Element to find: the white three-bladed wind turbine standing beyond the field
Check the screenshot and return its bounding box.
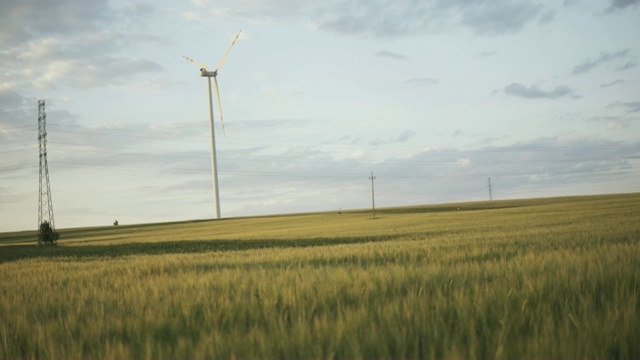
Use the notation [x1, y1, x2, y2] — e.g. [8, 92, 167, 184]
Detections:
[184, 30, 242, 219]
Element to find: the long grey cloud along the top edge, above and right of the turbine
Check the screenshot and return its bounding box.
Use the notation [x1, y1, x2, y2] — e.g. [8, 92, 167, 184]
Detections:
[184, 0, 553, 38]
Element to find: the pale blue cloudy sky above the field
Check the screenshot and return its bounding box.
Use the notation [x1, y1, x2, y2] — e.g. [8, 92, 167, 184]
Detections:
[0, 0, 640, 231]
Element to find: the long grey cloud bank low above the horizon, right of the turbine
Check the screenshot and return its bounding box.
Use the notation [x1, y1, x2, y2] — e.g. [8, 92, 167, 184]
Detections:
[239, 137, 640, 208]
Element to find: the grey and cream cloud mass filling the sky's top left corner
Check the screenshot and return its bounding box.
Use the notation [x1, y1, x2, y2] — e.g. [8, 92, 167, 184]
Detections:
[0, 0, 163, 90]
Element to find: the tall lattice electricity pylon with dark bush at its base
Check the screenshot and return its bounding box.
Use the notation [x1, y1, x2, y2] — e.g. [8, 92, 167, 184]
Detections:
[38, 100, 57, 244]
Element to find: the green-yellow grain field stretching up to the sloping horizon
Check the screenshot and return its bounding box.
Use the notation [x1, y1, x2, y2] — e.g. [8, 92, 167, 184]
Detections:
[0, 194, 640, 359]
